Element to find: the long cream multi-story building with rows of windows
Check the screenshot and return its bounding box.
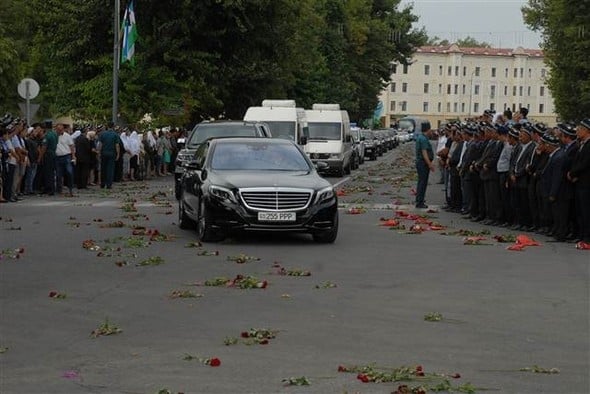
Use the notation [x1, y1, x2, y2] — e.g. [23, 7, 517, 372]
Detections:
[380, 44, 557, 127]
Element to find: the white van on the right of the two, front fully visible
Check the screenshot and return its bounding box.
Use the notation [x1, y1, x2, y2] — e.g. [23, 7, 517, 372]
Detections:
[305, 104, 354, 176]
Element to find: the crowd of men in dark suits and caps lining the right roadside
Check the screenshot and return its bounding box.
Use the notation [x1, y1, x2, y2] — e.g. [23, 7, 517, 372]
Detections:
[424, 108, 590, 242]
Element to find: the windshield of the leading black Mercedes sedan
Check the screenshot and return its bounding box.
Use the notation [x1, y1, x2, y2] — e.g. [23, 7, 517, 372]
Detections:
[211, 142, 310, 171]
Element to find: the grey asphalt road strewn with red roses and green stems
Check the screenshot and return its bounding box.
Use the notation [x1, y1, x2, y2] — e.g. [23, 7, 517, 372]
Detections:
[0, 144, 590, 394]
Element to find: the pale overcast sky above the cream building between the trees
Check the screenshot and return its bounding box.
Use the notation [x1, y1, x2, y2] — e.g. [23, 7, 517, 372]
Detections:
[401, 0, 541, 48]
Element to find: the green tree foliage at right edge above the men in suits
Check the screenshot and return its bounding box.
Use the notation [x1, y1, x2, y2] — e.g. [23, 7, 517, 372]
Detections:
[522, 0, 590, 120]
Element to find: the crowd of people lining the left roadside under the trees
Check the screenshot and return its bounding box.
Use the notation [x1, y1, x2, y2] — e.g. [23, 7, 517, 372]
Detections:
[0, 115, 183, 203]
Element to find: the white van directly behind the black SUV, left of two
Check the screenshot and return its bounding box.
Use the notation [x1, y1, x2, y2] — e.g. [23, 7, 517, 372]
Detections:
[244, 100, 308, 145]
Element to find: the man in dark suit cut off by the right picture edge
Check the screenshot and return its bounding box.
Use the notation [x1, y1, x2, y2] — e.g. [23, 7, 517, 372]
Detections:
[567, 118, 590, 242]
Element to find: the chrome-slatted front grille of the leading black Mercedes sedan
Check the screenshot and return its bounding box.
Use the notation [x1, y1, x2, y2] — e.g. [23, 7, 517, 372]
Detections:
[240, 187, 313, 211]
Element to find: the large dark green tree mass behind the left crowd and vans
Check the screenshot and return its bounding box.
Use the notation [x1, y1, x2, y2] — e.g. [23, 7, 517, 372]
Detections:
[0, 0, 426, 124]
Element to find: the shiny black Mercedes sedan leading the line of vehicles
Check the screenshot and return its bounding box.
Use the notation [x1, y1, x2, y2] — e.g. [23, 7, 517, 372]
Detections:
[178, 138, 338, 243]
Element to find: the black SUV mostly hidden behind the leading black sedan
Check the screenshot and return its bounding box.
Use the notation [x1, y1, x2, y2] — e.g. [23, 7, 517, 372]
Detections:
[174, 120, 272, 200]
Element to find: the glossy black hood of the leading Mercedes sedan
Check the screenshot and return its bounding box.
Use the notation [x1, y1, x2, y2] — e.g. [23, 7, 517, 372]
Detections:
[209, 171, 331, 190]
